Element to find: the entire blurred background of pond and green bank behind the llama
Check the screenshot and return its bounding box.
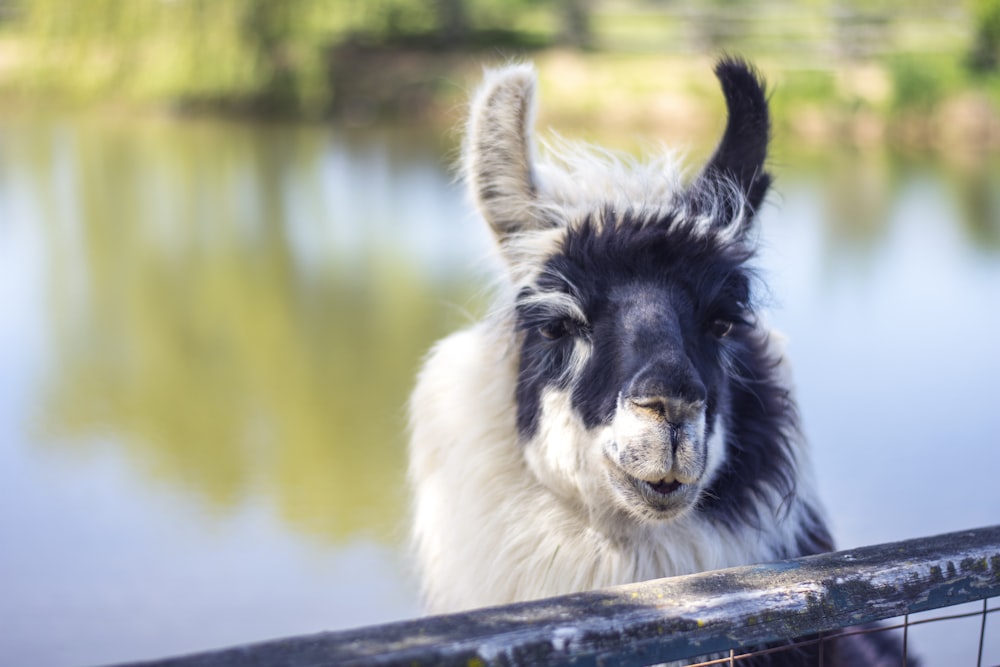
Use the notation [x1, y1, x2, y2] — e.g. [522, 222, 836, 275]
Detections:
[0, 0, 1000, 665]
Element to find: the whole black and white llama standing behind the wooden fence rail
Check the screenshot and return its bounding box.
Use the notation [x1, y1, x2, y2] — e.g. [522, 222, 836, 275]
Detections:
[409, 58, 898, 665]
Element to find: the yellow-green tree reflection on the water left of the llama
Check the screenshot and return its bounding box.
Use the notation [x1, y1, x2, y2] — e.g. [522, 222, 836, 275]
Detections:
[13, 116, 484, 540]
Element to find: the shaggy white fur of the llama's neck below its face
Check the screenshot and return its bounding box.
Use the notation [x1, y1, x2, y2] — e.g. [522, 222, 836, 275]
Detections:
[410, 325, 798, 612]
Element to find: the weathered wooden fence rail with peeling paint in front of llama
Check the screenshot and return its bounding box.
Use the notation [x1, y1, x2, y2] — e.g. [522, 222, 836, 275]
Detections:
[121, 526, 1000, 667]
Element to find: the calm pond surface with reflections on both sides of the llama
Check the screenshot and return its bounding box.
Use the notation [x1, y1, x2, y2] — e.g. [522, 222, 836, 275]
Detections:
[0, 119, 1000, 666]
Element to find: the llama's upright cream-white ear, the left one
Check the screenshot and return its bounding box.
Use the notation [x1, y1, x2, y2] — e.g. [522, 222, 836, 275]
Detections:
[463, 65, 543, 242]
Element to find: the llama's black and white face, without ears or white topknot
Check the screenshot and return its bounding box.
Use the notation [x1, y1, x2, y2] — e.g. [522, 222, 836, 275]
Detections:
[516, 219, 749, 520]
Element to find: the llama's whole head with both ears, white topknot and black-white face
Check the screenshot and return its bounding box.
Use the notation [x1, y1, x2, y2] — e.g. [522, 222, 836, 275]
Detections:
[464, 59, 770, 521]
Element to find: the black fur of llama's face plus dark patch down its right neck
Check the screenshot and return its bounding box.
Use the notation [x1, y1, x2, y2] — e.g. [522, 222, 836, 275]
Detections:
[508, 206, 830, 540]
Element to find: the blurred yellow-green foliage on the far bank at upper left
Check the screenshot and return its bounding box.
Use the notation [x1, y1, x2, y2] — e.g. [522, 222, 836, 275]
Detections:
[8, 0, 336, 112]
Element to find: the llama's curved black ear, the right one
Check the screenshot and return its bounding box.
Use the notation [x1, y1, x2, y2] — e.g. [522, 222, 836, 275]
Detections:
[688, 58, 771, 235]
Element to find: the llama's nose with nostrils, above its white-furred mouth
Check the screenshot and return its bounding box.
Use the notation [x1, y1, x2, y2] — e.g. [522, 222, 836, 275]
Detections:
[622, 361, 708, 423]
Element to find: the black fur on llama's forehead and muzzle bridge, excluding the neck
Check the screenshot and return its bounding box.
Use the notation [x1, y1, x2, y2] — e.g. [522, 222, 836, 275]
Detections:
[518, 213, 747, 436]
